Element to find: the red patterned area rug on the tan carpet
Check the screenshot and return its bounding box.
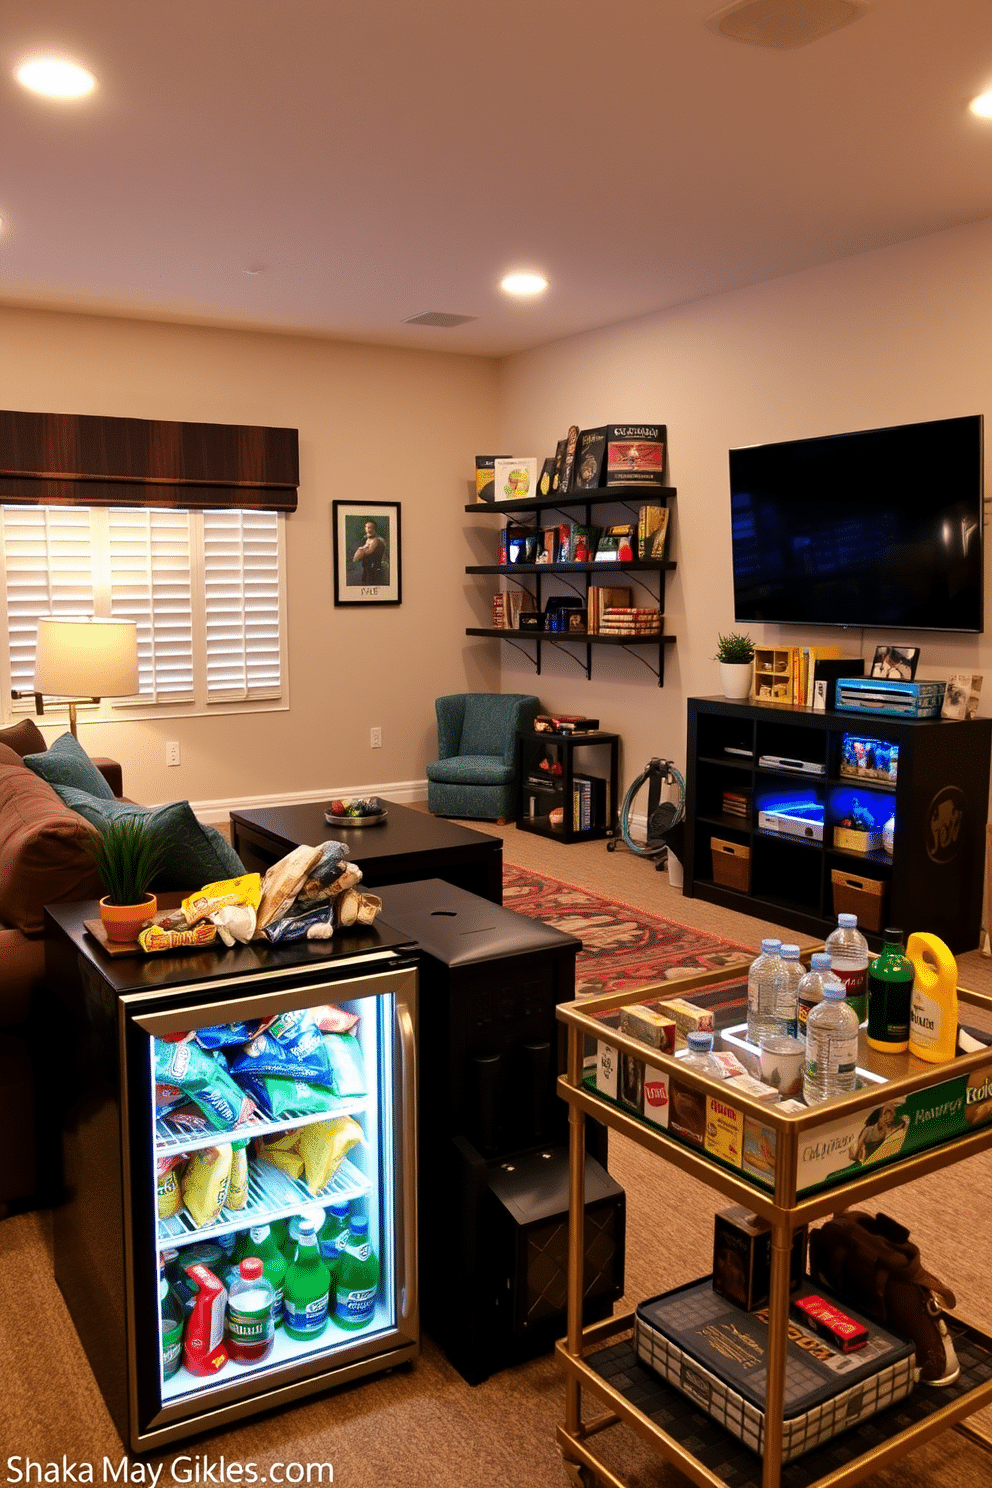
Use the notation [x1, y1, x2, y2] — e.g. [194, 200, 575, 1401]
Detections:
[503, 863, 756, 1000]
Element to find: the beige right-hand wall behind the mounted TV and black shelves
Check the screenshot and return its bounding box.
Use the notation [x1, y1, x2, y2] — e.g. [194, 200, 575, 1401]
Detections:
[500, 222, 992, 809]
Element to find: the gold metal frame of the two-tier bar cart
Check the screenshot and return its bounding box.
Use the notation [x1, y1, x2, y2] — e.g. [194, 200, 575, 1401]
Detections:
[558, 963, 992, 1488]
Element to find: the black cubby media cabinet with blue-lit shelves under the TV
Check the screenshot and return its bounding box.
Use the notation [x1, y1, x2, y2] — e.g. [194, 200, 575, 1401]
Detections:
[683, 698, 992, 952]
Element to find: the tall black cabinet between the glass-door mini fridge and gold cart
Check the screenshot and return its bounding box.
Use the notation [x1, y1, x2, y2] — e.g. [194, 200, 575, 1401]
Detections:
[381, 879, 626, 1384]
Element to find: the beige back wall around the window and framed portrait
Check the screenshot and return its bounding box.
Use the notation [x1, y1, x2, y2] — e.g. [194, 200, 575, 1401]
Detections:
[0, 310, 498, 805]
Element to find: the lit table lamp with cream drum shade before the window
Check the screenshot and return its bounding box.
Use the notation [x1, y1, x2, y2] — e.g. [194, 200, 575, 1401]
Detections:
[34, 615, 138, 738]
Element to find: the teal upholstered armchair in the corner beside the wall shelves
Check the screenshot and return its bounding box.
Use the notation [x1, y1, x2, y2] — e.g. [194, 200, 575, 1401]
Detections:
[427, 692, 541, 821]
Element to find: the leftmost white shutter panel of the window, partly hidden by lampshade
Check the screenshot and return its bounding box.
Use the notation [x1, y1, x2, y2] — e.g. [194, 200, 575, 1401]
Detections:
[0, 506, 94, 692]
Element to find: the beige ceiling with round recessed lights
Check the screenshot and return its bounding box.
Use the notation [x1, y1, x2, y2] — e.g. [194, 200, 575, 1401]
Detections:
[0, 0, 992, 354]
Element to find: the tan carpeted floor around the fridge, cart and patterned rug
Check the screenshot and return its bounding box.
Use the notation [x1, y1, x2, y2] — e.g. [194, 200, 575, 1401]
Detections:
[0, 823, 992, 1488]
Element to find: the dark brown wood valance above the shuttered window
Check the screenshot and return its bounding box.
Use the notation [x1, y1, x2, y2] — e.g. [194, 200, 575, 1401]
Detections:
[0, 409, 299, 512]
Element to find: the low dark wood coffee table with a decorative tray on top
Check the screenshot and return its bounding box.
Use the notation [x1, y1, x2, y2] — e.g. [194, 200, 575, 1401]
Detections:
[231, 801, 503, 905]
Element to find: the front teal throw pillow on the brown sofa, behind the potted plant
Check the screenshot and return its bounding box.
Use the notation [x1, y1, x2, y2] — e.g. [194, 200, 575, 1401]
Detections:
[55, 786, 245, 893]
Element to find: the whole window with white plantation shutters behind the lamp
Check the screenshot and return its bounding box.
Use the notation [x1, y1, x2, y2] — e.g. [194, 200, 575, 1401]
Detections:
[0, 504, 286, 713]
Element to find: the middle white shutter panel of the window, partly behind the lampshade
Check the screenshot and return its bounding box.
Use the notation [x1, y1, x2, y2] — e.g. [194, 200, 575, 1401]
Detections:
[107, 507, 195, 702]
